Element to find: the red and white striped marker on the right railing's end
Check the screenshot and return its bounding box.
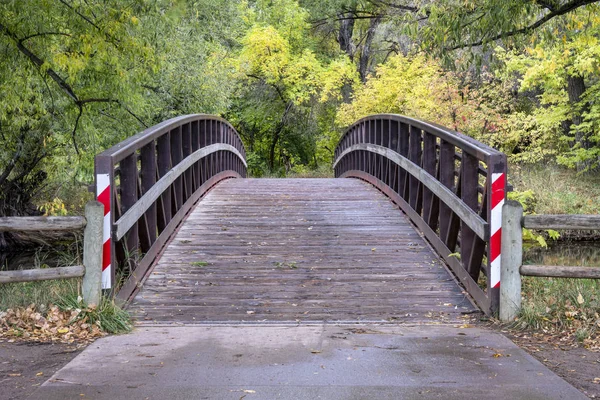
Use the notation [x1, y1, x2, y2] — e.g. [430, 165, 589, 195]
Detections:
[489, 172, 506, 289]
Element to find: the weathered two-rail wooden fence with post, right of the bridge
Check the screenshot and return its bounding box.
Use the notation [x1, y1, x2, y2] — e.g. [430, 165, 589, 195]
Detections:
[500, 201, 600, 321]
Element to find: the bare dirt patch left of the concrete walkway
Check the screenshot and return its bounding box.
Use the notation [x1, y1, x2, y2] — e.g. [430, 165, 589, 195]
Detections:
[0, 341, 83, 400]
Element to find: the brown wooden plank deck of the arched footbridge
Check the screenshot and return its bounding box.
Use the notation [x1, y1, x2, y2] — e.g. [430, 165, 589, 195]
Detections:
[130, 179, 475, 323]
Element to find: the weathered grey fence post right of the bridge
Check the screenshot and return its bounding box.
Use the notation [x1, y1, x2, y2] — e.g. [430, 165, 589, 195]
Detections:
[500, 200, 523, 322]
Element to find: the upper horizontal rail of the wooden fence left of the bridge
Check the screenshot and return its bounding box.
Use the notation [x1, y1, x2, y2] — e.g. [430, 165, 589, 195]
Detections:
[0, 217, 85, 232]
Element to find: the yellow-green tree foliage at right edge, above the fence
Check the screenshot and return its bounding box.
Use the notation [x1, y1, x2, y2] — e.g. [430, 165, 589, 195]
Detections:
[497, 7, 600, 170]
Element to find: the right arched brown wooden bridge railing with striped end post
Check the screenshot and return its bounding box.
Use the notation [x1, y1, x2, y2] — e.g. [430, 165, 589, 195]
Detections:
[334, 114, 506, 314]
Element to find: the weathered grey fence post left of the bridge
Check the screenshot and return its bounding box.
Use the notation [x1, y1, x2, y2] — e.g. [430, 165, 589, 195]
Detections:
[82, 201, 104, 305]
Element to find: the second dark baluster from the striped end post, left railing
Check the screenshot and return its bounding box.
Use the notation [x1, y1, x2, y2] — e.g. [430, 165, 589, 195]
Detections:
[140, 141, 156, 253]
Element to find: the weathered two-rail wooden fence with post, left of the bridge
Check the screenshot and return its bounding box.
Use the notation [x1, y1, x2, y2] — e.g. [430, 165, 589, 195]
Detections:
[0, 201, 104, 304]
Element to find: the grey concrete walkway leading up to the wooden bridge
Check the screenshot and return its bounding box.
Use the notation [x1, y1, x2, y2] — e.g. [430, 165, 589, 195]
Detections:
[31, 325, 586, 400]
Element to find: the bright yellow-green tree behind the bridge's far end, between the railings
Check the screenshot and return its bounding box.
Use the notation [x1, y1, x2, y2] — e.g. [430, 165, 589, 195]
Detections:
[231, 0, 356, 172]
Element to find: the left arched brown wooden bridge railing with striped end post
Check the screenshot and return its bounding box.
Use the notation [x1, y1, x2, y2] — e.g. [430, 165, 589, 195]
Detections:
[95, 114, 247, 301]
